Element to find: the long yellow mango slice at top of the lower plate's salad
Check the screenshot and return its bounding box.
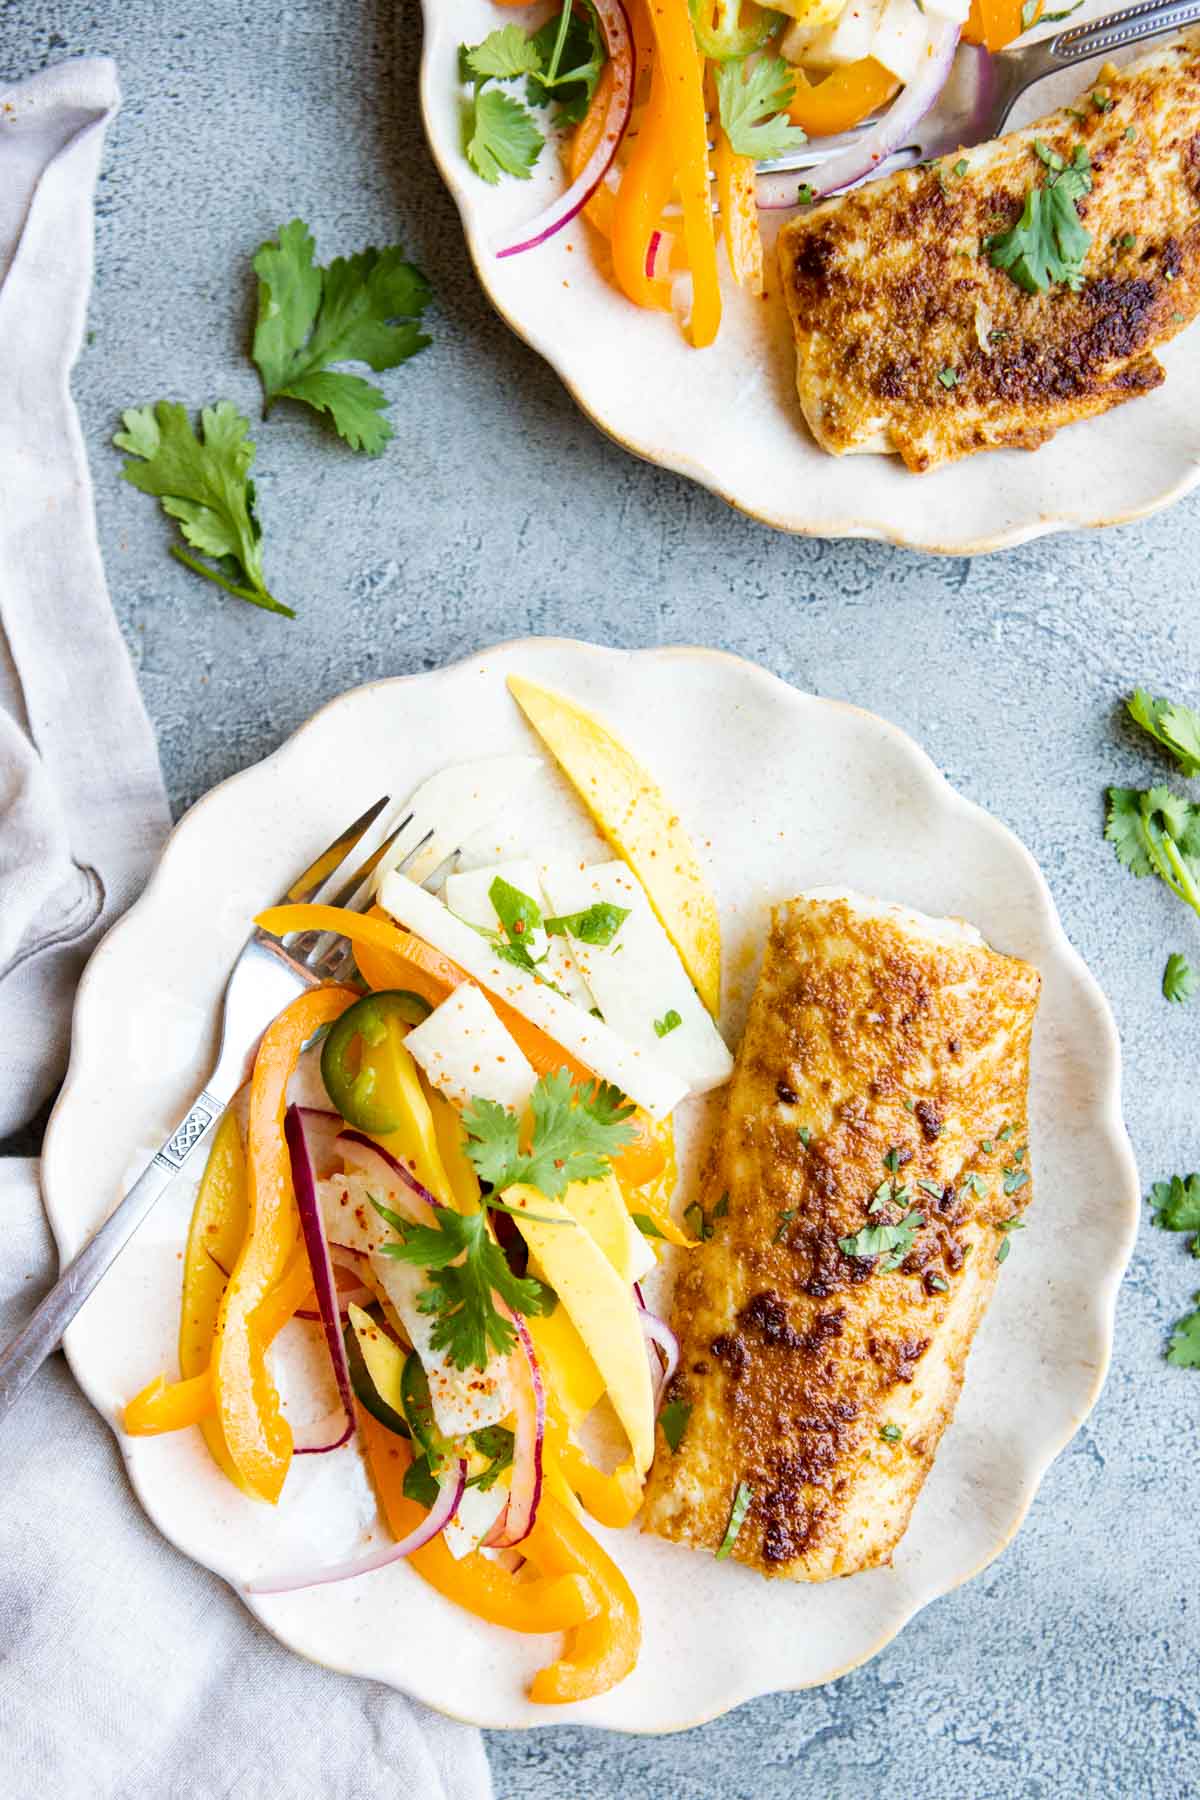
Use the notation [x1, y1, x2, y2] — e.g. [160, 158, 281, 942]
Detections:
[507, 675, 721, 1017]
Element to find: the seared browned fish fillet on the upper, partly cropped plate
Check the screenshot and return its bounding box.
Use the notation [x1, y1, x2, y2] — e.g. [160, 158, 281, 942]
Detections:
[779, 31, 1200, 470]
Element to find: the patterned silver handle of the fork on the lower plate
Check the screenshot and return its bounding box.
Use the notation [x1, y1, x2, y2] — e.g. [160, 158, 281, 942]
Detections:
[0, 1087, 227, 1420]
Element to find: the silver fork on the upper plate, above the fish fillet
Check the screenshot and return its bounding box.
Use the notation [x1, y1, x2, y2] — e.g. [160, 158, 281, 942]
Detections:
[759, 0, 1200, 175]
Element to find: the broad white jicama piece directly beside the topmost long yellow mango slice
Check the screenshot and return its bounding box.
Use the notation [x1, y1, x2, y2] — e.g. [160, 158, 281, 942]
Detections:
[542, 860, 734, 1094]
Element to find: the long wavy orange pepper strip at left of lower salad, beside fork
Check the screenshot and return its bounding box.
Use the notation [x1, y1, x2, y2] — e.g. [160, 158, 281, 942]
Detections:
[212, 988, 358, 1505]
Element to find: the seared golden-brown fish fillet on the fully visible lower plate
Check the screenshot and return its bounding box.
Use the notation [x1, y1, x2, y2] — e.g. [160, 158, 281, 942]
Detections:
[644, 889, 1040, 1580]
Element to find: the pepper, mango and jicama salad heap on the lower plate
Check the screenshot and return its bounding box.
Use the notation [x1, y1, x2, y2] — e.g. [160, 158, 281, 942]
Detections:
[124, 679, 730, 1703]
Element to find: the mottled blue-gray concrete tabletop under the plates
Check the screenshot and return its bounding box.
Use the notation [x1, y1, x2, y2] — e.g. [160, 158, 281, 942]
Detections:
[0, 0, 1200, 1800]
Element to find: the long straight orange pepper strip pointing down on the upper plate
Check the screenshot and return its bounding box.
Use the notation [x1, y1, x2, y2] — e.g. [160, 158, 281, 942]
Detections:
[647, 0, 721, 349]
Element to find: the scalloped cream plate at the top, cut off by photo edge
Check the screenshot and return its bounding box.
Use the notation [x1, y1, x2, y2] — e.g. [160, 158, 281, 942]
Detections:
[421, 0, 1200, 554]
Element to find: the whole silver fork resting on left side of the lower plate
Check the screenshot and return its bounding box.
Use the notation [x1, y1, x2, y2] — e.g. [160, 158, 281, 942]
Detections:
[0, 794, 433, 1420]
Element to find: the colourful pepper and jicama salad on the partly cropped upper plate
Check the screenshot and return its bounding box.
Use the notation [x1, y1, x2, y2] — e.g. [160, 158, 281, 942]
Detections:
[459, 0, 1081, 349]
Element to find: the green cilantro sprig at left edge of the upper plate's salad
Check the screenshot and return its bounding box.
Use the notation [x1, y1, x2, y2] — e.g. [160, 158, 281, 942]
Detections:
[459, 0, 606, 185]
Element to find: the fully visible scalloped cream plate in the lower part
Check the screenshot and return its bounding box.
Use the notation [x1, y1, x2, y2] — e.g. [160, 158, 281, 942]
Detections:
[44, 639, 1139, 1732]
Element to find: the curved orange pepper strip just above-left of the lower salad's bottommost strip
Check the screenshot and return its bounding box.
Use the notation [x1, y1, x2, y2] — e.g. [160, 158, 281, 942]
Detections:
[358, 1408, 599, 1633]
